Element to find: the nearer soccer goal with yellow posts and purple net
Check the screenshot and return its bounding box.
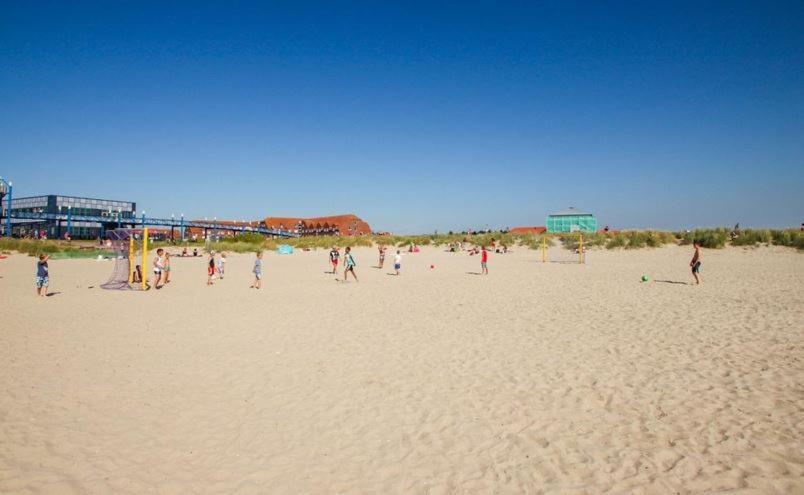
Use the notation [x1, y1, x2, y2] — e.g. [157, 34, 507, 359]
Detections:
[101, 228, 150, 290]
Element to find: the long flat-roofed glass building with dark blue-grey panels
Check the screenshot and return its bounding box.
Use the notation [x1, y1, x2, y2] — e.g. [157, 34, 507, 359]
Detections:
[3, 194, 137, 239]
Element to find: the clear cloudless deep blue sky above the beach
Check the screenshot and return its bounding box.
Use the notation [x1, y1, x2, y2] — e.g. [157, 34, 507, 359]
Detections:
[0, 1, 804, 233]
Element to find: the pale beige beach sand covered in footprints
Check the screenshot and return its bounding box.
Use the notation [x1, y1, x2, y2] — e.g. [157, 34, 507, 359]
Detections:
[0, 247, 804, 494]
